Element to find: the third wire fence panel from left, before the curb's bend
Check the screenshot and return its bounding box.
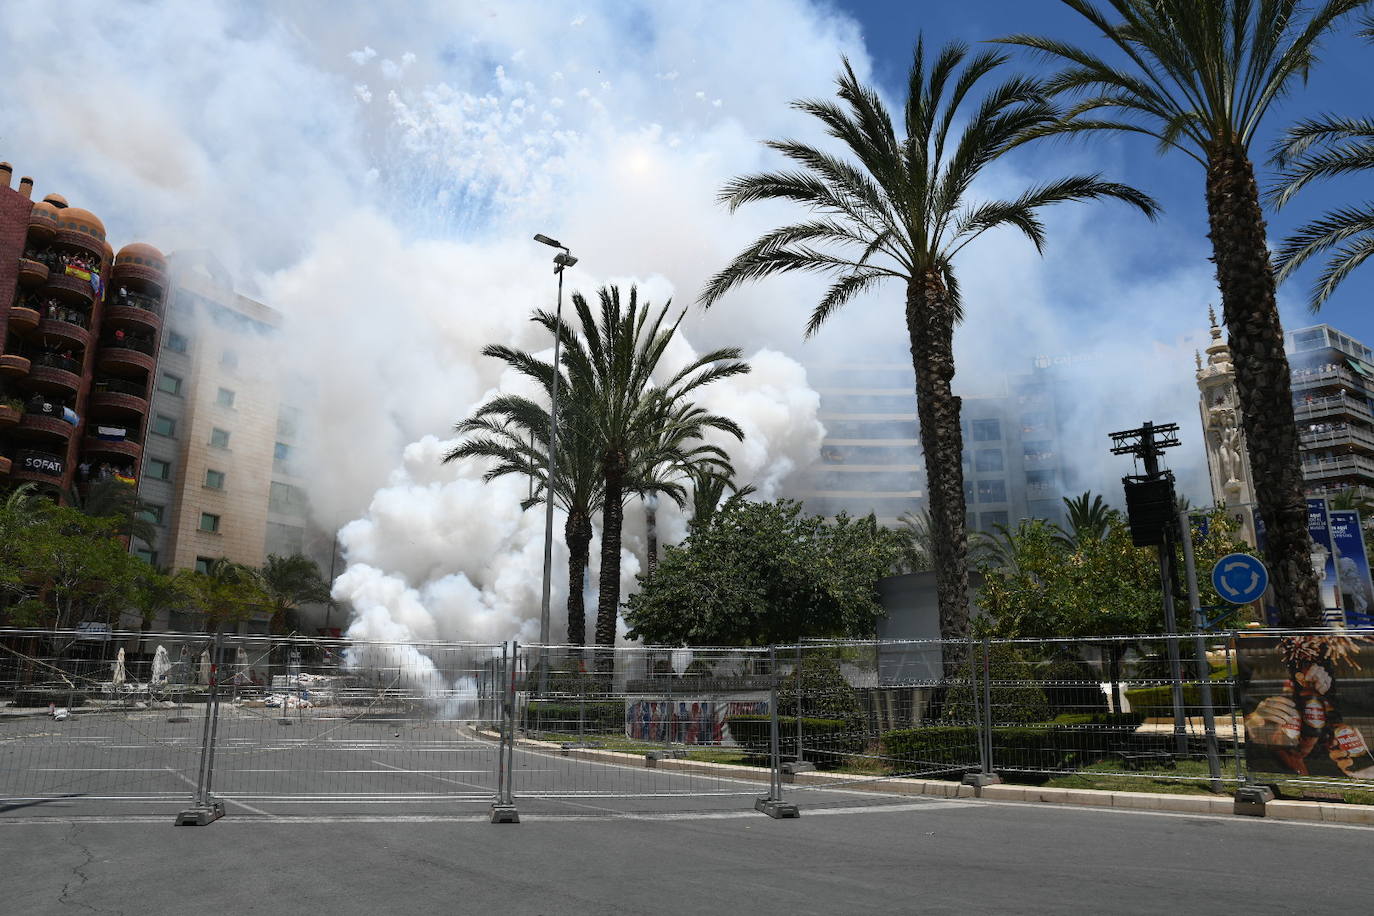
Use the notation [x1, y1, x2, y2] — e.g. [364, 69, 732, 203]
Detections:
[514, 645, 774, 813]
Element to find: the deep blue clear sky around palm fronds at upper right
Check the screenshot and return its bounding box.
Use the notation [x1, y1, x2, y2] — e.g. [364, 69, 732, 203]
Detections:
[831, 0, 1374, 343]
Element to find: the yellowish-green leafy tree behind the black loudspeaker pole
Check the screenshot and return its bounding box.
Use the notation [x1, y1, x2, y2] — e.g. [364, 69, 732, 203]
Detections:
[980, 509, 1248, 709]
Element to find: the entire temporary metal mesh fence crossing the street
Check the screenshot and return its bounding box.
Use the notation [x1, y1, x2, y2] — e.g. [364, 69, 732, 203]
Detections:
[0, 630, 1374, 823]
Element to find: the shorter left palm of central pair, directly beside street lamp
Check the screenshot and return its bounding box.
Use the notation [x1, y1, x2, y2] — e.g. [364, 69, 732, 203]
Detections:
[444, 368, 602, 645]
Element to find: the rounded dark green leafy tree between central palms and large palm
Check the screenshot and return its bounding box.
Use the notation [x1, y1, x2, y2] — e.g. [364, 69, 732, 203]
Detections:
[625, 496, 899, 645]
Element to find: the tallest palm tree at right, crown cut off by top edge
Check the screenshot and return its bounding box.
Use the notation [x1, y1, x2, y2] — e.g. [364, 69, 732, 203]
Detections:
[1000, 0, 1367, 625]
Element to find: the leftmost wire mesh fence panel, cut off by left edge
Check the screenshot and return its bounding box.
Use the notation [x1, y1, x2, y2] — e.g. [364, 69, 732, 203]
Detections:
[0, 629, 209, 814]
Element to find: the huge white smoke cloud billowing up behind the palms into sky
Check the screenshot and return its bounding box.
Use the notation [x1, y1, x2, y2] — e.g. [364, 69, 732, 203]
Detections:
[0, 0, 1231, 640]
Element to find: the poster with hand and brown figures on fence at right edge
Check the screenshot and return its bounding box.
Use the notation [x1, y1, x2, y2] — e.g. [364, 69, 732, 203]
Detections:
[1237, 630, 1374, 781]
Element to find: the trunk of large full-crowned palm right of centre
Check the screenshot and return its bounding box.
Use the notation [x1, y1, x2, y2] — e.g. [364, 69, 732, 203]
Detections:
[907, 269, 969, 645]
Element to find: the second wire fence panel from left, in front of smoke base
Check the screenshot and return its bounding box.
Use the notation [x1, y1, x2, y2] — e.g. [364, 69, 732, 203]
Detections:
[200, 636, 503, 805]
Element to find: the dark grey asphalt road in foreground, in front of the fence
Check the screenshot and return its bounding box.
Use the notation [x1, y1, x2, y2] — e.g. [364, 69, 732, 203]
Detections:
[0, 799, 1374, 916]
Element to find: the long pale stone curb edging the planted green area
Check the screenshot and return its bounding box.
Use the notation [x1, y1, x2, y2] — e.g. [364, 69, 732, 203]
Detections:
[478, 732, 1374, 827]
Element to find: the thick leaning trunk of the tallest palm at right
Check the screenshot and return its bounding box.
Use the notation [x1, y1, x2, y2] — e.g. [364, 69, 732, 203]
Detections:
[1206, 147, 1322, 626]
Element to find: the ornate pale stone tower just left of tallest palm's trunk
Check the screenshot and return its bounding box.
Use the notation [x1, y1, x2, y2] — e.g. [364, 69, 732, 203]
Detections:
[1197, 306, 1254, 545]
